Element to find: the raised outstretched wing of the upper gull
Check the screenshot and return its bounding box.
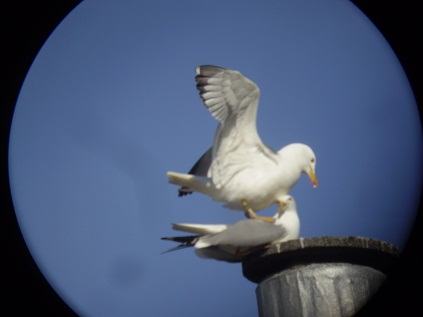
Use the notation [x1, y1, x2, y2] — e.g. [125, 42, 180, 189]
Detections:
[195, 66, 277, 188]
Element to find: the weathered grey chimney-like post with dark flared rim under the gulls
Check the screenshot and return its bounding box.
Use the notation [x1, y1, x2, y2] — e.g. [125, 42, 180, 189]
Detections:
[243, 237, 399, 317]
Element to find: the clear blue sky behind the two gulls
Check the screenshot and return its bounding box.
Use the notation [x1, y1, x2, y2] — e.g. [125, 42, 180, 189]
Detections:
[10, 0, 422, 316]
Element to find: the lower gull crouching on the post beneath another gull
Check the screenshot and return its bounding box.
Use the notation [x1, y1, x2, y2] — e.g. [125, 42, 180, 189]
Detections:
[162, 195, 300, 262]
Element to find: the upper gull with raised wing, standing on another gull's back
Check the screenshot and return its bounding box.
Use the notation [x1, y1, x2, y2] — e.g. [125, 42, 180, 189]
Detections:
[167, 65, 318, 222]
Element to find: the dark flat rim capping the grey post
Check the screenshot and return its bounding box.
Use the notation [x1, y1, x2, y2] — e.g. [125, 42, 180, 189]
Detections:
[242, 237, 400, 283]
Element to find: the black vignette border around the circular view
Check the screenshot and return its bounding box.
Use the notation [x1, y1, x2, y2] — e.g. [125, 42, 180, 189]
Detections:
[0, 0, 423, 317]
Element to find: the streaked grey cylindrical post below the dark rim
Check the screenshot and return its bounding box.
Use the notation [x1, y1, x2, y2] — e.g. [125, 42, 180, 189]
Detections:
[256, 263, 386, 317]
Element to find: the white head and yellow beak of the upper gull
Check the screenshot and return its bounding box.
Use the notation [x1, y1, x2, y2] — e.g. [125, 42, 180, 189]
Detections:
[280, 143, 318, 188]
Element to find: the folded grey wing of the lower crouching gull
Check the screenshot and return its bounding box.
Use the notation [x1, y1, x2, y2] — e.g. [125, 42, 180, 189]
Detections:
[200, 219, 287, 247]
